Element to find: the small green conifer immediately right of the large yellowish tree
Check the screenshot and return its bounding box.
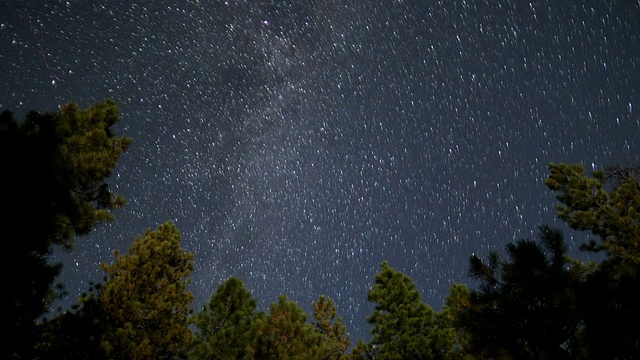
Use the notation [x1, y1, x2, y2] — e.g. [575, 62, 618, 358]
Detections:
[190, 277, 256, 359]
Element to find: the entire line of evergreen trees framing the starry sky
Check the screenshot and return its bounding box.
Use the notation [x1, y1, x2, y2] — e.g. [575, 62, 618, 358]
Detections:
[0, 100, 640, 360]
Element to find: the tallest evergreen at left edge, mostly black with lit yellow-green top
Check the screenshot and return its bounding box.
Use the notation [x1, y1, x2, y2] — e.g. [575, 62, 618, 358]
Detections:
[0, 100, 130, 358]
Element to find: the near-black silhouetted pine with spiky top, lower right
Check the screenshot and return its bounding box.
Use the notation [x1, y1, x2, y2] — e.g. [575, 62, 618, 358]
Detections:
[459, 226, 581, 359]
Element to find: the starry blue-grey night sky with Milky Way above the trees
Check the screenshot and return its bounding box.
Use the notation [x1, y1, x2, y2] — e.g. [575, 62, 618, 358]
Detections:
[0, 0, 640, 340]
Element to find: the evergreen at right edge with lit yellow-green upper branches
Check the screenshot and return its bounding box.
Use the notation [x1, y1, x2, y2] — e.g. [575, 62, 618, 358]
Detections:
[545, 164, 640, 359]
